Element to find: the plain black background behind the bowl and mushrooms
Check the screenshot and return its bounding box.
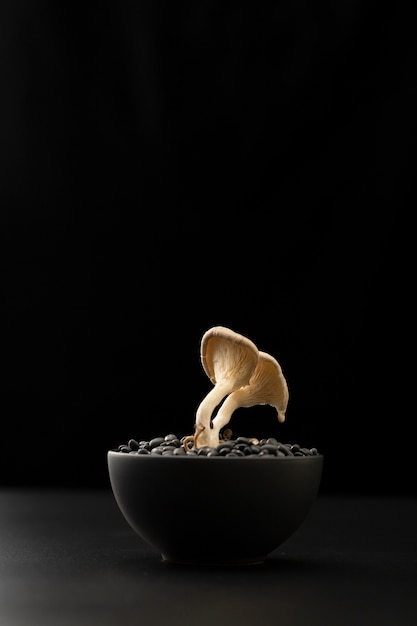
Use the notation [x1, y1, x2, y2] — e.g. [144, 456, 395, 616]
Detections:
[0, 0, 416, 493]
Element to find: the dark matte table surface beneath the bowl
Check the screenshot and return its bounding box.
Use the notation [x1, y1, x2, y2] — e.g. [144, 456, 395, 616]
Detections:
[0, 489, 417, 626]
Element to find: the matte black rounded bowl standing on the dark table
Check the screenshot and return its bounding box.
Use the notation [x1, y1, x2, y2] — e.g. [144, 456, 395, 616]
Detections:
[107, 451, 323, 565]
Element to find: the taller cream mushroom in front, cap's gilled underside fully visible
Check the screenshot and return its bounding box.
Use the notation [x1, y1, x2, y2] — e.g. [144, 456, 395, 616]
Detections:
[193, 326, 259, 448]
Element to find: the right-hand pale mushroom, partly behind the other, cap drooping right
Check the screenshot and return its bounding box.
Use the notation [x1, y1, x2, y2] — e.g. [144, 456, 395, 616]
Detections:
[213, 351, 289, 432]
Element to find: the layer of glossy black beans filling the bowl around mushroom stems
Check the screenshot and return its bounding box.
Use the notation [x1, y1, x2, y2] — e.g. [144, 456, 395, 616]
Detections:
[115, 434, 319, 457]
